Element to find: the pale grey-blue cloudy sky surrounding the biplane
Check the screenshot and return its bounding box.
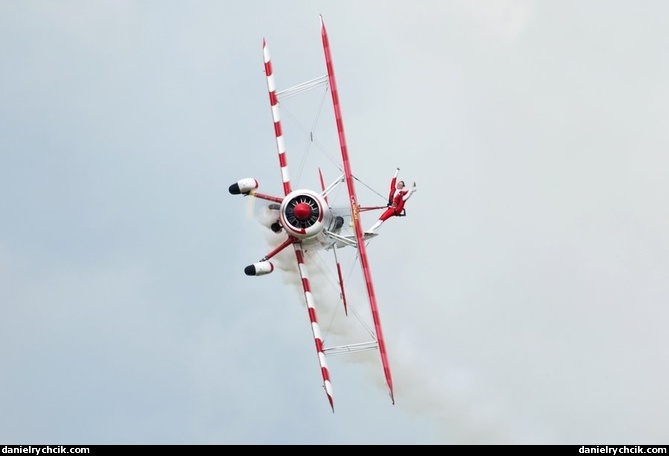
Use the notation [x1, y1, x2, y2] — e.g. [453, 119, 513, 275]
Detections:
[0, 0, 669, 444]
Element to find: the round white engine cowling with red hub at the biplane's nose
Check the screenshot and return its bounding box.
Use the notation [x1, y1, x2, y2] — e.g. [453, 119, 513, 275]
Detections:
[279, 190, 332, 239]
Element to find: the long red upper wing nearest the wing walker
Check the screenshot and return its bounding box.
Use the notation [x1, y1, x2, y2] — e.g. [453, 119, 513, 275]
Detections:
[318, 16, 395, 404]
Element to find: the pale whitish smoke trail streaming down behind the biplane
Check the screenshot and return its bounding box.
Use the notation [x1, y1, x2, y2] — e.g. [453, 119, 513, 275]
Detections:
[253, 208, 546, 444]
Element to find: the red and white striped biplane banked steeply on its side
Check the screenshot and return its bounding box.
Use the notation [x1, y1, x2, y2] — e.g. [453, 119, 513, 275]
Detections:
[229, 16, 395, 412]
